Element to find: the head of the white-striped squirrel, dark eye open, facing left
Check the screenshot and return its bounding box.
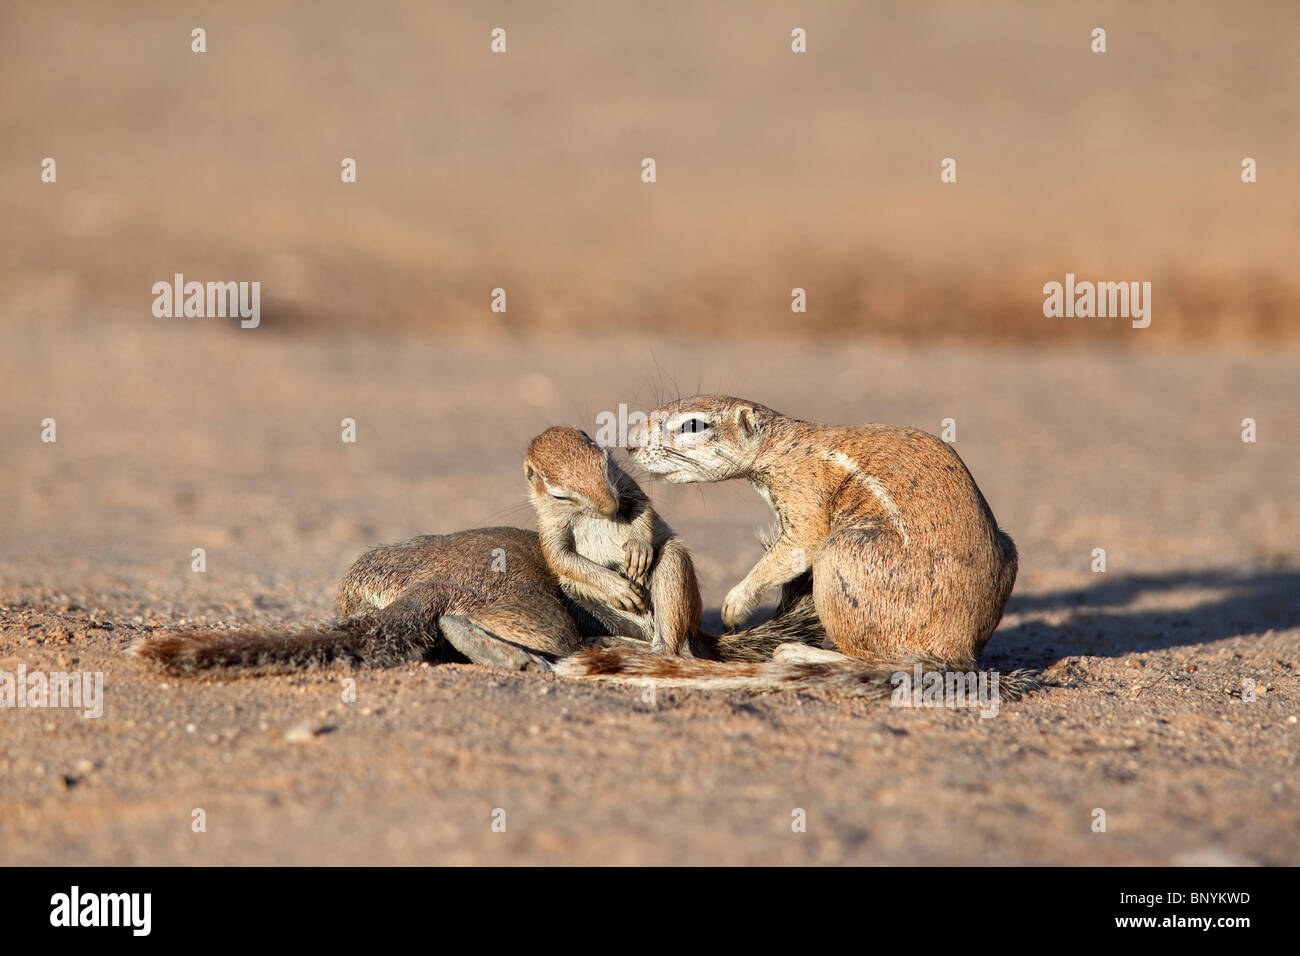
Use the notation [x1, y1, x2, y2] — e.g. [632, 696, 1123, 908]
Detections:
[628, 395, 780, 483]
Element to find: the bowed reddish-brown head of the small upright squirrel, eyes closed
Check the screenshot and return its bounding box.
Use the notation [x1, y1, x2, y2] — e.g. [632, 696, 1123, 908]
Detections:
[524, 425, 619, 518]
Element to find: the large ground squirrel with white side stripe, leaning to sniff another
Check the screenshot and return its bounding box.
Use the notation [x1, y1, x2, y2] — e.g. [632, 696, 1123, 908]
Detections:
[568, 395, 1017, 687]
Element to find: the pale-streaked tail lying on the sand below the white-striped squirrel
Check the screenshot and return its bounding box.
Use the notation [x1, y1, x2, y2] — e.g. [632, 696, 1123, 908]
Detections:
[555, 645, 1039, 700]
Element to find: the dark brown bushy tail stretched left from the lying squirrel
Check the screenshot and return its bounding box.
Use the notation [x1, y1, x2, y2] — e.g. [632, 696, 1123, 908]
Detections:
[130, 615, 437, 676]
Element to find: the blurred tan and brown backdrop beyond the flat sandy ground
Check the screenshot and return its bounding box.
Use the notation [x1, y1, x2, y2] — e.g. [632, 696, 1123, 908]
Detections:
[0, 1, 1300, 347]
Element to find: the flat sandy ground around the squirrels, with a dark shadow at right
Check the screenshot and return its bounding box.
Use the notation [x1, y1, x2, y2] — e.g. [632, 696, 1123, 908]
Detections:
[0, 316, 1300, 864]
